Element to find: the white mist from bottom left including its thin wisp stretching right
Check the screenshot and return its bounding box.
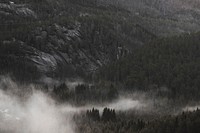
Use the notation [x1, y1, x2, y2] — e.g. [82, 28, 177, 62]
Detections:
[0, 77, 153, 133]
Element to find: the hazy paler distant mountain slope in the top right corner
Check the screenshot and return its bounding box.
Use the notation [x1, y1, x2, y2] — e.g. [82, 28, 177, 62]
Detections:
[104, 0, 200, 36]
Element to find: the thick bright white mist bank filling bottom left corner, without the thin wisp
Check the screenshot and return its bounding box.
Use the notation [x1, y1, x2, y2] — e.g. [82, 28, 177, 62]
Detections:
[0, 91, 74, 133]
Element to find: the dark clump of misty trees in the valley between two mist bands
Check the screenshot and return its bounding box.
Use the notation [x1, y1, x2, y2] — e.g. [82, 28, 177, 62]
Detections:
[52, 83, 119, 105]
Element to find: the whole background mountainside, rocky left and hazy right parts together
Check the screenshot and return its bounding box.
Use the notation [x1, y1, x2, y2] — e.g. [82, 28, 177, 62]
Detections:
[0, 0, 200, 80]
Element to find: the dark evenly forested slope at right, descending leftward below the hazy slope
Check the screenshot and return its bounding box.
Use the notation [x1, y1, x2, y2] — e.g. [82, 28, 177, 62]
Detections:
[98, 33, 200, 101]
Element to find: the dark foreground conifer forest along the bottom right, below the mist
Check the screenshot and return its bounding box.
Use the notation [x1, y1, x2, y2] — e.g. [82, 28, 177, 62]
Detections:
[75, 108, 200, 133]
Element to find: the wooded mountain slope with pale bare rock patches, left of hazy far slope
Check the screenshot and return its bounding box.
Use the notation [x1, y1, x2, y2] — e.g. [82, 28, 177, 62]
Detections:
[0, 0, 155, 79]
